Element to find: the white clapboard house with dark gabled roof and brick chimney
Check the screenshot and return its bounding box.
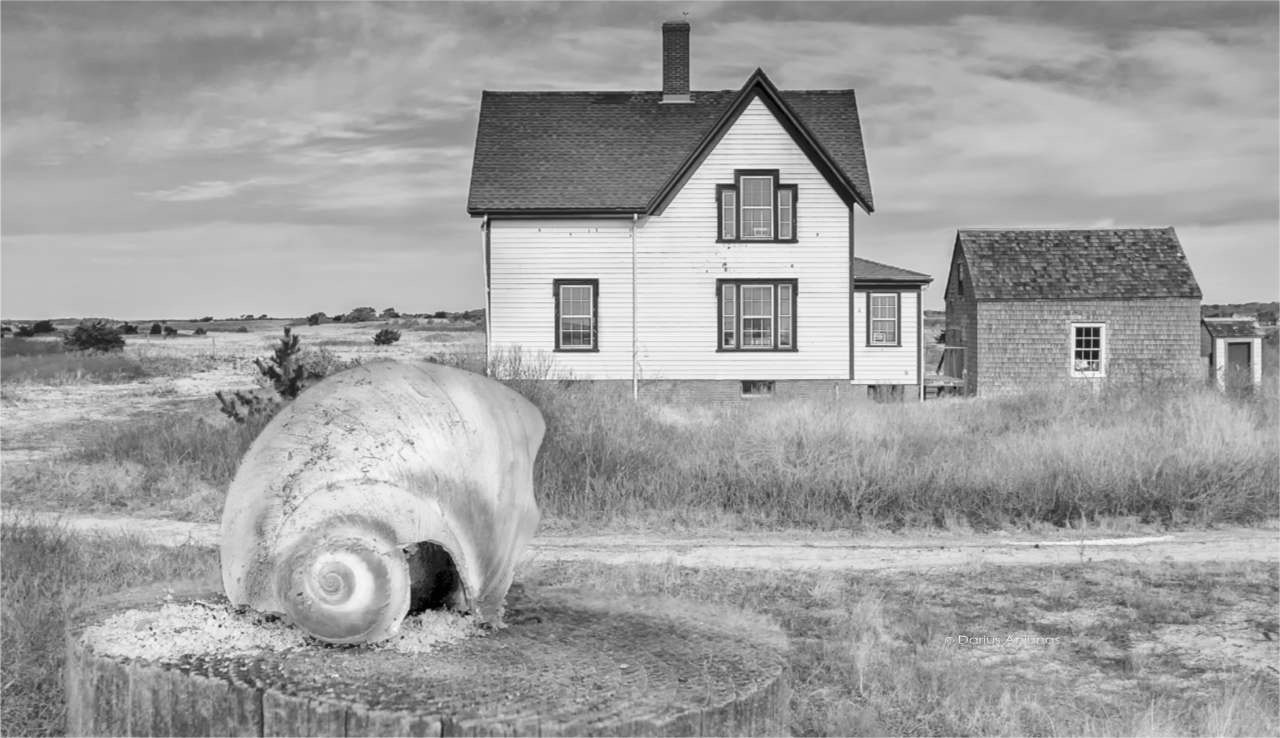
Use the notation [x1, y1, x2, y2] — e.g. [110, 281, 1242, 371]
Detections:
[467, 22, 931, 400]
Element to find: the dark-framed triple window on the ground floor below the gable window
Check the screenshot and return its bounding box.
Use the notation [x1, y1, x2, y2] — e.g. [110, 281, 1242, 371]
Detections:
[716, 279, 796, 350]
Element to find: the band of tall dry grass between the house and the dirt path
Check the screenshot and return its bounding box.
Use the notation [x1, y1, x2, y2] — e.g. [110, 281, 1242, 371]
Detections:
[522, 382, 1280, 527]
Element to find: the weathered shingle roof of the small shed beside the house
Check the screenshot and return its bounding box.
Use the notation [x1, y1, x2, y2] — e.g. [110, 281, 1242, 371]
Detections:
[947, 228, 1201, 299]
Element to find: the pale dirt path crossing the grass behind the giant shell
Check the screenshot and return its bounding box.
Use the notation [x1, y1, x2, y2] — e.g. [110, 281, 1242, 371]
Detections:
[4, 510, 1280, 570]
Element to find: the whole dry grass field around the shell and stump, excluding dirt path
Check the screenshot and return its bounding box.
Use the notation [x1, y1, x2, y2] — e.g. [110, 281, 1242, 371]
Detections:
[0, 321, 1280, 735]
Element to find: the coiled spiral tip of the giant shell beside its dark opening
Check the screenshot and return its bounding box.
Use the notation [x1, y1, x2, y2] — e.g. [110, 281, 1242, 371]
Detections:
[276, 522, 411, 643]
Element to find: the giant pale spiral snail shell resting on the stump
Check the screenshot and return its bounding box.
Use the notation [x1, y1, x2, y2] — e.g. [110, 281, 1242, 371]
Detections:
[221, 362, 545, 643]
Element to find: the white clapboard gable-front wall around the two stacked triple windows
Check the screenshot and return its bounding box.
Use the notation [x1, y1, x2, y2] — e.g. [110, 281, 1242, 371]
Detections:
[636, 100, 850, 380]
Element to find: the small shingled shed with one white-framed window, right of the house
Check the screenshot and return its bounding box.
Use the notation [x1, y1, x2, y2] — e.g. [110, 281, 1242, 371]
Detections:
[943, 228, 1203, 395]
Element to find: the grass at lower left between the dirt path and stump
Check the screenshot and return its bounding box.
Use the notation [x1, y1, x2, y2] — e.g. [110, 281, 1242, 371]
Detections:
[0, 522, 218, 735]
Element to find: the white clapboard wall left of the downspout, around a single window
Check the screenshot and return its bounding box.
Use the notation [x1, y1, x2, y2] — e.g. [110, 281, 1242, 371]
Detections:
[489, 219, 631, 379]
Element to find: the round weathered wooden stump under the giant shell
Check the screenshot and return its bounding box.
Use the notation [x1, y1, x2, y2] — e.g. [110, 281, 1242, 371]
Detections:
[67, 586, 790, 735]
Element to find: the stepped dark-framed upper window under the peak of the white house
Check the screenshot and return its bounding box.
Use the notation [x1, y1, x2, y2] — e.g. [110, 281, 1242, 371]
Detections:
[716, 169, 796, 242]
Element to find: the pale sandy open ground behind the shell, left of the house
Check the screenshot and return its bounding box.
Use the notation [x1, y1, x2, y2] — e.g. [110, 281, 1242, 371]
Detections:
[0, 322, 484, 463]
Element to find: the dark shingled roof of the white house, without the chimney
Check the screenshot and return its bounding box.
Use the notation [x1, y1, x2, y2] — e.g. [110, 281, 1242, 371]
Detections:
[467, 69, 873, 215]
